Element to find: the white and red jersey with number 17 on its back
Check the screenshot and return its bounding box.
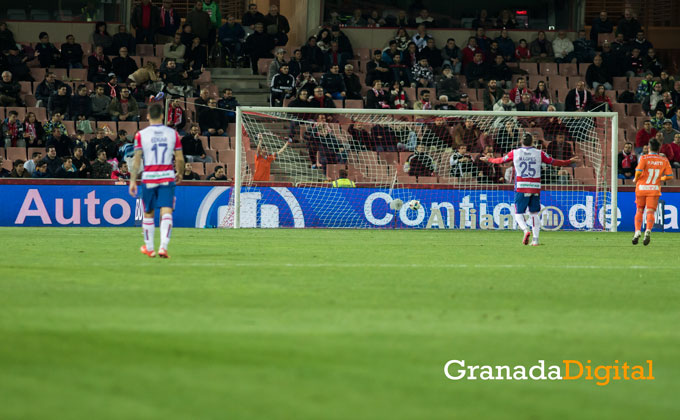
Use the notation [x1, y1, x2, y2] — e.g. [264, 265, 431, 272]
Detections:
[135, 125, 182, 184]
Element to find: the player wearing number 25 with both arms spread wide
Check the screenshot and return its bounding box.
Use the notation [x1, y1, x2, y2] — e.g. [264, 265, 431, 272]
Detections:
[480, 134, 578, 246]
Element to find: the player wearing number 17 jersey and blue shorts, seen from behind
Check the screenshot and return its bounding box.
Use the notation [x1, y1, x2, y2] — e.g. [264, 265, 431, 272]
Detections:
[130, 104, 184, 258]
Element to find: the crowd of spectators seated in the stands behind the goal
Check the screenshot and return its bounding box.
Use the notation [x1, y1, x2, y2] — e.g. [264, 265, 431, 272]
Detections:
[0, 0, 680, 180]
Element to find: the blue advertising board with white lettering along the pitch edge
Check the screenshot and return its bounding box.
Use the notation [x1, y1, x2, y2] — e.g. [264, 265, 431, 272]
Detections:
[0, 182, 680, 232]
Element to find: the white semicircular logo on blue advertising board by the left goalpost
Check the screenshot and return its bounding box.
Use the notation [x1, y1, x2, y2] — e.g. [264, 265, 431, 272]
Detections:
[195, 187, 305, 228]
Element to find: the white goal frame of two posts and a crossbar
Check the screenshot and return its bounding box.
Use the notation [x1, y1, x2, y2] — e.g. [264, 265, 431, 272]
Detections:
[233, 106, 619, 232]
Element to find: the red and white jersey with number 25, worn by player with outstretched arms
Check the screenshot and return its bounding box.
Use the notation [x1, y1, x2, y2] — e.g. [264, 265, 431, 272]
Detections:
[489, 146, 571, 194]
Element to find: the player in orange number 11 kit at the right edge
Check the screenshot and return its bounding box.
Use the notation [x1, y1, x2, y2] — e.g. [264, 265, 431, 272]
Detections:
[633, 139, 673, 245]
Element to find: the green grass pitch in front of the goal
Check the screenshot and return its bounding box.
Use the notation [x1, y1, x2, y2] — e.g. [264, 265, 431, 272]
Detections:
[0, 228, 680, 419]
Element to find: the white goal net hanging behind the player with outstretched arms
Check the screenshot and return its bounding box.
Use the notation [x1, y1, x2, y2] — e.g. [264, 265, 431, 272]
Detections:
[226, 107, 618, 230]
